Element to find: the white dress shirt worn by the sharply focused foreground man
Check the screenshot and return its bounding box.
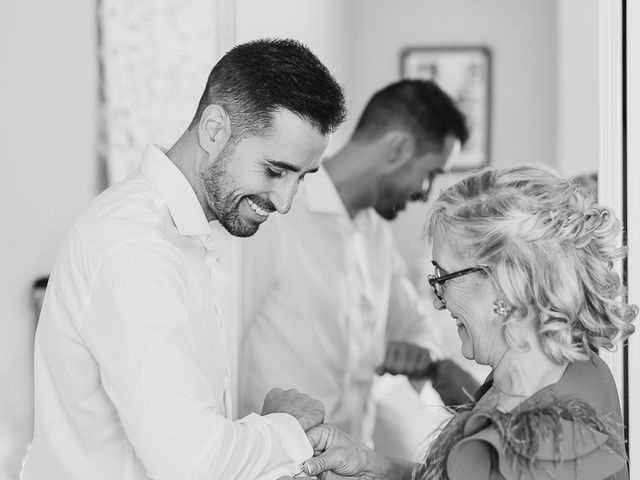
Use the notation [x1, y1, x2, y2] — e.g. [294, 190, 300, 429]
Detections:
[22, 147, 312, 480]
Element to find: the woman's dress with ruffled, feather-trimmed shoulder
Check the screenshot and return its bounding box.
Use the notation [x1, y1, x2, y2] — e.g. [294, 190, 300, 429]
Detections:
[414, 357, 627, 480]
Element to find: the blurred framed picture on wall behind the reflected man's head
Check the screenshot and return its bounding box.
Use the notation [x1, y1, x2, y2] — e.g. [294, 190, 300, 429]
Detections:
[400, 46, 491, 171]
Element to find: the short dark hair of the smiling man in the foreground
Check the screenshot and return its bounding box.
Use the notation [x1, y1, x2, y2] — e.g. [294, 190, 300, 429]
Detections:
[189, 39, 346, 141]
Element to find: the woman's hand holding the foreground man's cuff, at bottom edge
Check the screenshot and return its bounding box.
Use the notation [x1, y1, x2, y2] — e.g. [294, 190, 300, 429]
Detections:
[304, 423, 413, 480]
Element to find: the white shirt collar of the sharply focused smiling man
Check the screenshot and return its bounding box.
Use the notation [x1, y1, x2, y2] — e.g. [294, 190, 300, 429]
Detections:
[138, 145, 214, 236]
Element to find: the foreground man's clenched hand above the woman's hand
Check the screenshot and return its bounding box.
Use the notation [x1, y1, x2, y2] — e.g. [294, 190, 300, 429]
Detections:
[262, 388, 324, 432]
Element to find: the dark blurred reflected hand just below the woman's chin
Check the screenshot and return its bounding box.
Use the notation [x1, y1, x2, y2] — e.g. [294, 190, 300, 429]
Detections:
[429, 359, 480, 406]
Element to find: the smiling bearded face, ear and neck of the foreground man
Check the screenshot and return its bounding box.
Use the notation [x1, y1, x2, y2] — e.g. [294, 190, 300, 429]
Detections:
[167, 105, 328, 237]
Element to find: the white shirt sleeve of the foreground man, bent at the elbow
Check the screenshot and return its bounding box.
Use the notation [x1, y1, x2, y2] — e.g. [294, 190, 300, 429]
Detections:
[80, 242, 312, 480]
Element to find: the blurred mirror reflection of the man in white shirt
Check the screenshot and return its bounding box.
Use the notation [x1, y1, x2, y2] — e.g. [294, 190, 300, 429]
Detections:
[239, 80, 477, 440]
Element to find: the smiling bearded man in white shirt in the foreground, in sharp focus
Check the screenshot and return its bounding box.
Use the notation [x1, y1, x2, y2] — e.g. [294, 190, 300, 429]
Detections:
[22, 40, 344, 480]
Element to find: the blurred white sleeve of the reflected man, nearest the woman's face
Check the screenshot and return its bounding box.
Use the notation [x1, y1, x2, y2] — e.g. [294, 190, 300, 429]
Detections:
[387, 232, 442, 358]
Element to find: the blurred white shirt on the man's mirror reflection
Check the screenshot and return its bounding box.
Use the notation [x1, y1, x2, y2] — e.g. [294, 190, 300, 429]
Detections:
[239, 168, 438, 440]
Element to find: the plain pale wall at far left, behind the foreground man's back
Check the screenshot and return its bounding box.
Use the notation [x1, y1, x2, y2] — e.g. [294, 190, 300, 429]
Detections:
[0, 0, 99, 480]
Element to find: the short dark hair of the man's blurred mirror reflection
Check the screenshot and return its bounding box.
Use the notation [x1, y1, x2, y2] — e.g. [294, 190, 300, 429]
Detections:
[352, 80, 469, 152]
